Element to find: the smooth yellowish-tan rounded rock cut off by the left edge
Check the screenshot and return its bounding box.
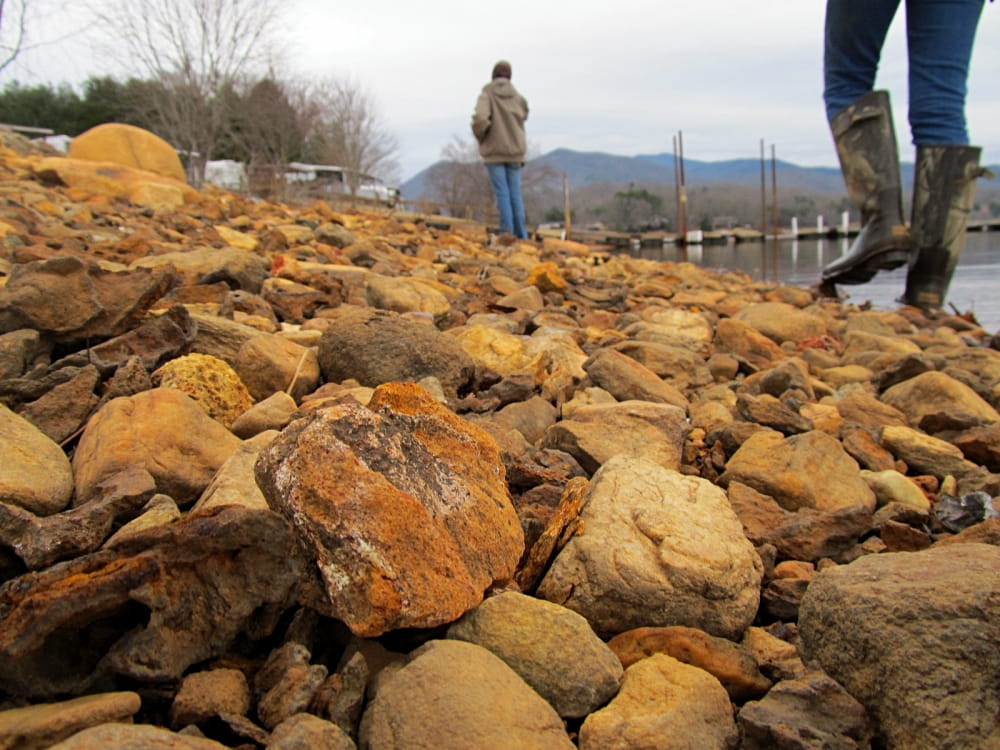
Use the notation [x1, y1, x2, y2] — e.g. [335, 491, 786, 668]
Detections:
[0, 404, 73, 516]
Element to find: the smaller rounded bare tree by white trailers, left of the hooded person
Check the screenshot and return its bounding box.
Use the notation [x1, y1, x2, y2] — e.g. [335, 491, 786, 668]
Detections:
[311, 78, 399, 194]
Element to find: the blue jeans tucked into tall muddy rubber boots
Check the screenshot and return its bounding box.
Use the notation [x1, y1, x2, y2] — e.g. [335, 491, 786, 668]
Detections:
[823, 0, 984, 145]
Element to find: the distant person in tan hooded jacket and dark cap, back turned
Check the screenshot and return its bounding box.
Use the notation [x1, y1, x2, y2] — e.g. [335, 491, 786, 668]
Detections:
[472, 60, 528, 244]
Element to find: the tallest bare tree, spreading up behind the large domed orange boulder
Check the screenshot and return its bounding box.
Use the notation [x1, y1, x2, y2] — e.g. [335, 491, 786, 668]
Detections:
[96, 0, 284, 185]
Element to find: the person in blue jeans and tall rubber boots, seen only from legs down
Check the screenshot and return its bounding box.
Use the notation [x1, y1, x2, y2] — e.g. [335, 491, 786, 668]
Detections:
[821, 0, 989, 311]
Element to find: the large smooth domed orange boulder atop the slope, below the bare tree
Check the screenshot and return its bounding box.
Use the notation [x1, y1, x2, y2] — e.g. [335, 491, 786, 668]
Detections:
[68, 122, 185, 182]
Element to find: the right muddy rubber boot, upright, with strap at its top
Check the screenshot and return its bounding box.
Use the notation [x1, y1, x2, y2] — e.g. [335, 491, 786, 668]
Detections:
[903, 146, 992, 311]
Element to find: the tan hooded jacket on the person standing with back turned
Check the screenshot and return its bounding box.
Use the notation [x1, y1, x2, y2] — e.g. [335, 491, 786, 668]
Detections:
[472, 78, 528, 164]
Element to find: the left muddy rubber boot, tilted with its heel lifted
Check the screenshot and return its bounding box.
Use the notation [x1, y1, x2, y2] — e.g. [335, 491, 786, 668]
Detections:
[822, 91, 912, 286]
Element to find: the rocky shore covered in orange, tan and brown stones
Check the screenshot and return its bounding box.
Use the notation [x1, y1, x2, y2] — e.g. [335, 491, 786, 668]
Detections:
[0, 128, 1000, 750]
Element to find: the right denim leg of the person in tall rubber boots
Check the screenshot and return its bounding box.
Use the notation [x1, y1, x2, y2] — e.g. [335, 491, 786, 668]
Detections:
[906, 0, 983, 146]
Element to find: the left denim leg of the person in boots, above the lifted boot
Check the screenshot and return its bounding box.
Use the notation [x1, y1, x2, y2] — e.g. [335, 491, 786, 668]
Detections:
[823, 0, 900, 120]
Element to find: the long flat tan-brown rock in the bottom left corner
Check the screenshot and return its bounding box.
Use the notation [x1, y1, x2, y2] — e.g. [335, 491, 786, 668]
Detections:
[0, 692, 141, 750]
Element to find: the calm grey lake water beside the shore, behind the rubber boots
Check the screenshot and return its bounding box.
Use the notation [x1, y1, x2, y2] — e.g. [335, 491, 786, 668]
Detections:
[635, 232, 1000, 333]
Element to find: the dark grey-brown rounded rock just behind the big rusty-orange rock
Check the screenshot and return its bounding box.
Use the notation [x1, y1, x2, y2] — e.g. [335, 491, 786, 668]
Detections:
[319, 311, 475, 394]
